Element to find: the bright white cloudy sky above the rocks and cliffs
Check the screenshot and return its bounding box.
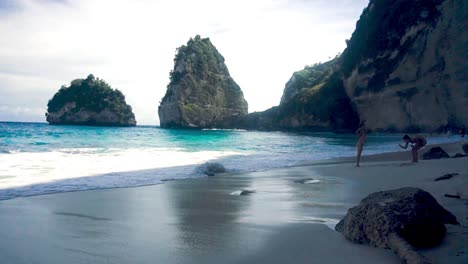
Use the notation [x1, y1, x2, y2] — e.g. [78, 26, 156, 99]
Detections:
[0, 0, 368, 125]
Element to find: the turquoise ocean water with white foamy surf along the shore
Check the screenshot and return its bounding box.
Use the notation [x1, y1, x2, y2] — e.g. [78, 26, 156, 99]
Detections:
[0, 122, 459, 200]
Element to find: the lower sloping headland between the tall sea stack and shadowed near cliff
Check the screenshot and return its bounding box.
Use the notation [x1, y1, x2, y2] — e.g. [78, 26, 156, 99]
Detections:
[231, 62, 359, 131]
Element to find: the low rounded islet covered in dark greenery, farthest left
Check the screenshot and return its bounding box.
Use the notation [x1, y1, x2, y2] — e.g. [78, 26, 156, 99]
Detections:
[46, 74, 136, 126]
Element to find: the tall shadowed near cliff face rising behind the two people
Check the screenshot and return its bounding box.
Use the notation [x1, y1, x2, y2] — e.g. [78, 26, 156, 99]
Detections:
[341, 0, 468, 131]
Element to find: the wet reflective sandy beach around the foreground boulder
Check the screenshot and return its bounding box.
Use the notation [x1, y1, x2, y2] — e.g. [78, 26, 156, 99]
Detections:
[0, 141, 468, 264]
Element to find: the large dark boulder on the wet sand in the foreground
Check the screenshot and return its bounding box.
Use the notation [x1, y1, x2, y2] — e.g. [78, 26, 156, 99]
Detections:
[335, 187, 458, 263]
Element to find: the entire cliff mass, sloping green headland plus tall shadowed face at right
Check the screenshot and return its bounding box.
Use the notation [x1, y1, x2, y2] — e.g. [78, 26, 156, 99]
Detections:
[239, 0, 468, 132]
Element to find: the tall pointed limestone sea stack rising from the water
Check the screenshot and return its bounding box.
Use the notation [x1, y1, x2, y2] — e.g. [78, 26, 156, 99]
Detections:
[158, 35, 248, 129]
